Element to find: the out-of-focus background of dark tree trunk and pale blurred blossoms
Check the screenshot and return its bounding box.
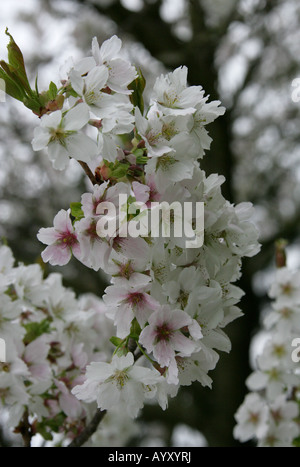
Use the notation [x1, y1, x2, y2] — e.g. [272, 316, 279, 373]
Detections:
[0, 0, 300, 446]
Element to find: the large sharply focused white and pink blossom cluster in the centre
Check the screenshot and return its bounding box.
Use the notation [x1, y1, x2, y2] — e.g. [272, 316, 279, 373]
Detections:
[29, 36, 259, 417]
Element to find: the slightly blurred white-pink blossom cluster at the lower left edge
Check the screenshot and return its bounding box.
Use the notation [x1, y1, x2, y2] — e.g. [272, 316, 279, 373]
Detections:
[0, 246, 125, 439]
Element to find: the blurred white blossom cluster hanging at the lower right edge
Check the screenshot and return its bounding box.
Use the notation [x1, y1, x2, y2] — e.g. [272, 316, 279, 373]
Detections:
[234, 266, 300, 447]
